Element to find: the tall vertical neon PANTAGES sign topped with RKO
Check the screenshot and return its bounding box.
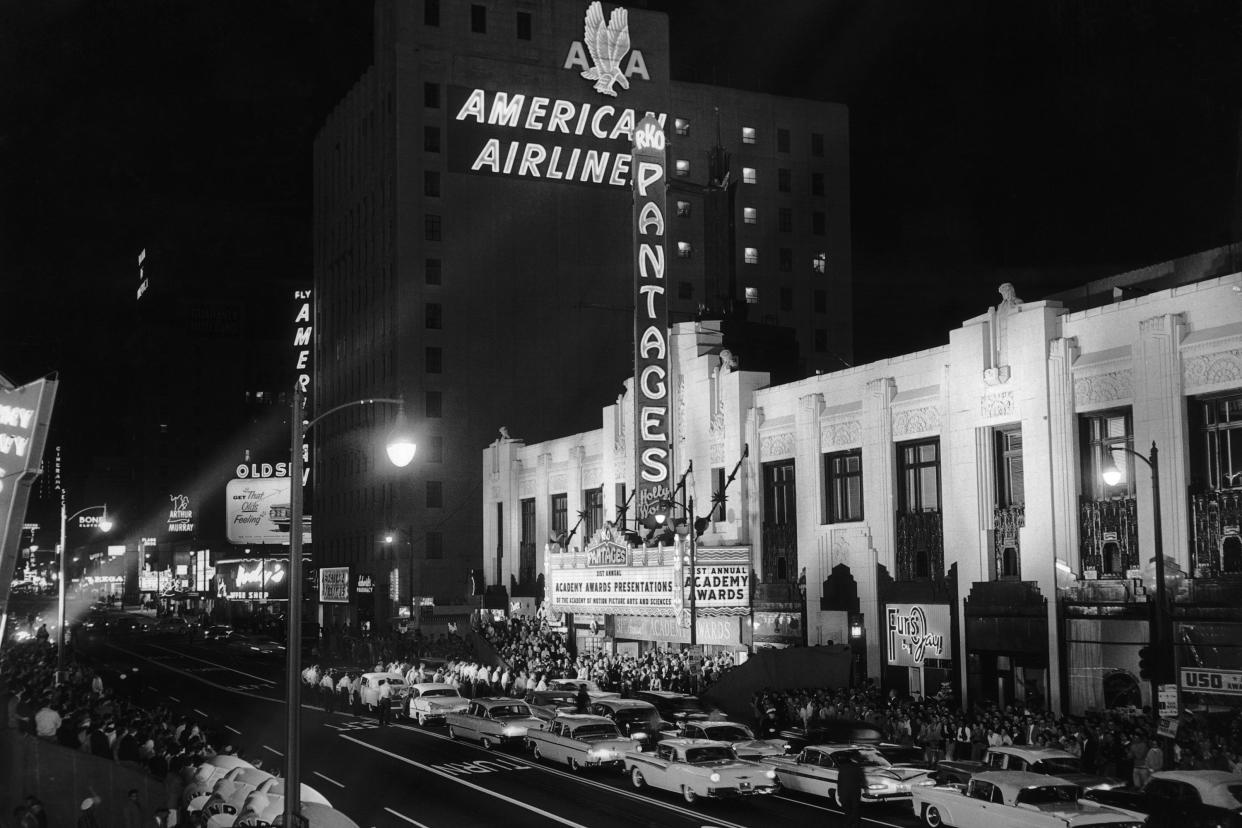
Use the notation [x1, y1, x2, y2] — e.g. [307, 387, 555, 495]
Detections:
[633, 114, 672, 519]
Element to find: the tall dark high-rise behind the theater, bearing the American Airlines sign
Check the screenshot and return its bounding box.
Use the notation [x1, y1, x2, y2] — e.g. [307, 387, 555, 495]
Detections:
[313, 0, 852, 620]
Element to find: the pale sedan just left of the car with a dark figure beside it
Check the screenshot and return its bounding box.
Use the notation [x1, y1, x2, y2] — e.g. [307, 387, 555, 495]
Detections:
[625, 739, 777, 802]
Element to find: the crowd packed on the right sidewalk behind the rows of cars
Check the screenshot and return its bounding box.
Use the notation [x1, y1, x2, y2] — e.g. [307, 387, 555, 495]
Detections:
[751, 685, 1242, 786]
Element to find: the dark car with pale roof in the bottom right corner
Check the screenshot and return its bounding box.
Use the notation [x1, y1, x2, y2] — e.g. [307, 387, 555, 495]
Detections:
[1083, 771, 1242, 828]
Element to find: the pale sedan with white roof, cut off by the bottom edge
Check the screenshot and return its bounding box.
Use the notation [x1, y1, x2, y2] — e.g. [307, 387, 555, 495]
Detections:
[912, 771, 1143, 828]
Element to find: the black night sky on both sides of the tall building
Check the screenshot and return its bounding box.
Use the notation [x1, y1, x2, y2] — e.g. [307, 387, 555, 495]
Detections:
[0, 0, 1242, 466]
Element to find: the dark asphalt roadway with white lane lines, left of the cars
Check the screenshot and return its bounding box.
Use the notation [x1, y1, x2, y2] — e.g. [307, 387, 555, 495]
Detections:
[82, 633, 918, 828]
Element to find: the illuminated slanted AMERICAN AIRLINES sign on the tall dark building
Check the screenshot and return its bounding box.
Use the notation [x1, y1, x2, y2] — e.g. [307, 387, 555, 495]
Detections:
[448, 87, 666, 187]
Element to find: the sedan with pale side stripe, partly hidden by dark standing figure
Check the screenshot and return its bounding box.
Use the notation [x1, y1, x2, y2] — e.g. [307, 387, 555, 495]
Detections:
[760, 745, 935, 803]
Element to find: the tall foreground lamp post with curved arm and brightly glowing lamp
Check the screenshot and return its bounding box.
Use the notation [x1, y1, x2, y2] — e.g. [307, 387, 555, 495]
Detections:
[284, 387, 417, 828]
